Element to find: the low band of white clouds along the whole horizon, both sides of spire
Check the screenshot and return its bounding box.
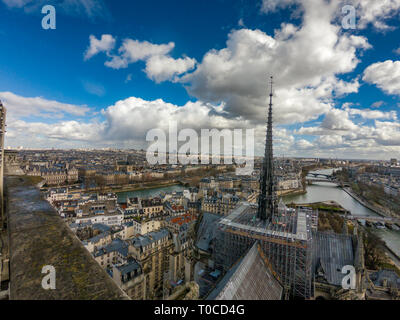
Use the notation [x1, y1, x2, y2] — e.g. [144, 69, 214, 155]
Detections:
[4, 89, 400, 158]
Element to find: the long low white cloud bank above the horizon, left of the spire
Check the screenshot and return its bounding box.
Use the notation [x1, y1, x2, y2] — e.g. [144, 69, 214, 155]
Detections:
[4, 97, 250, 147]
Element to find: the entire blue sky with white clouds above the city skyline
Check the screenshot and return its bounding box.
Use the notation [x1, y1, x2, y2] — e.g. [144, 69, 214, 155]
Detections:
[0, 0, 400, 159]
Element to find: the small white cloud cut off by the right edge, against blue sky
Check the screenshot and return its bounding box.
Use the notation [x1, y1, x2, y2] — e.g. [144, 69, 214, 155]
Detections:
[363, 60, 400, 95]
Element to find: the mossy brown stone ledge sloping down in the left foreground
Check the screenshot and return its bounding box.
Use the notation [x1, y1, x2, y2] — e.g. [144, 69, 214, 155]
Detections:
[5, 176, 129, 300]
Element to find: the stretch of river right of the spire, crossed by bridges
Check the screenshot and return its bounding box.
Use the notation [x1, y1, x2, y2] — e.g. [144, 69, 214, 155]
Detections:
[283, 169, 400, 257]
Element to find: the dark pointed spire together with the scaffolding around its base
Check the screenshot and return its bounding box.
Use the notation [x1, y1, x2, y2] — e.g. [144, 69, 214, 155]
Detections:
[214, 77, 318, 299]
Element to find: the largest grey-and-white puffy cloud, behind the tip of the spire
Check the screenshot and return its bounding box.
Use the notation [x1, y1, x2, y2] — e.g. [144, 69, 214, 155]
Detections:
[180, 1, 370, 123]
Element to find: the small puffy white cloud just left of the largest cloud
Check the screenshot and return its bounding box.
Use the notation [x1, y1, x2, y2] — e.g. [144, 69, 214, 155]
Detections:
[145, 55, 196, 83]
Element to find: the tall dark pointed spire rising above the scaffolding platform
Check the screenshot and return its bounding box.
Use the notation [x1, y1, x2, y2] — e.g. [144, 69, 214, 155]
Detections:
[257, 77, 277, 221]
